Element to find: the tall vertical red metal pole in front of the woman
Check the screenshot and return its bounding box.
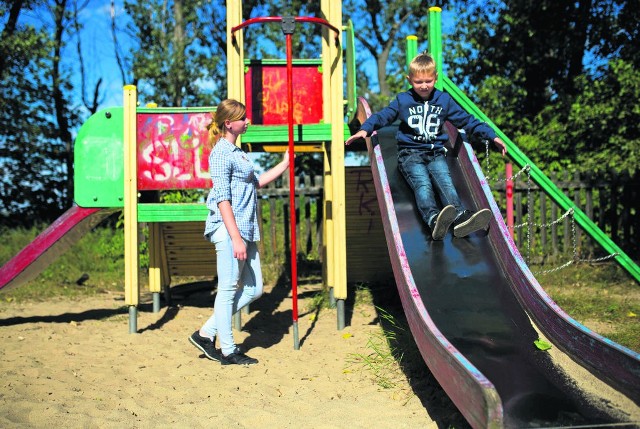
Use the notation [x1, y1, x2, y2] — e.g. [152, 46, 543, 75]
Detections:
[285, 34, 298, 332]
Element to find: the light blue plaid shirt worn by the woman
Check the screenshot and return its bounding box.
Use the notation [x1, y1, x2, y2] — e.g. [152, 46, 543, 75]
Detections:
[204, 138, 260, 241]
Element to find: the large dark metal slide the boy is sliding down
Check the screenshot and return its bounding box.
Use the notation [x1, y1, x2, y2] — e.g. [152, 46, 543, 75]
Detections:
[358, 100, 640, 428]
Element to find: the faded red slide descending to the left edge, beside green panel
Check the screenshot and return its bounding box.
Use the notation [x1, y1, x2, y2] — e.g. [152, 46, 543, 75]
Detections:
[0, 206, 114, 289]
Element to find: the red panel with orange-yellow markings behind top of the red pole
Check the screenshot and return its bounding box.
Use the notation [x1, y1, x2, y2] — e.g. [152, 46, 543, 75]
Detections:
[244, 63, 323, 125]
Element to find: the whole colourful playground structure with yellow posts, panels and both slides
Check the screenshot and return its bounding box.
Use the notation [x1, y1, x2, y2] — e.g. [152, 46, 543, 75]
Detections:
[0, 0, 640, 427]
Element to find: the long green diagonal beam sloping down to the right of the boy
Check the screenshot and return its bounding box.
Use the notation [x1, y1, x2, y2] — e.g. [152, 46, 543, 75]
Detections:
[440, 76, 640, 282]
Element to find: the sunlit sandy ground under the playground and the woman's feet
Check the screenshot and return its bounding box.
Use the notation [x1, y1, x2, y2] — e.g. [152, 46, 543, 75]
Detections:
[0, 283, 467, 428]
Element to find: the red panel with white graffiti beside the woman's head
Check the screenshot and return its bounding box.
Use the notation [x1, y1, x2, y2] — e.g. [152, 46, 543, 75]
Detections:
[137, 113, 211, 190]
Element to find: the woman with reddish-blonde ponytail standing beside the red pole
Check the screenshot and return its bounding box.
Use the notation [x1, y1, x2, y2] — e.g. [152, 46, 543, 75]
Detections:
[189, 99, 289, 365]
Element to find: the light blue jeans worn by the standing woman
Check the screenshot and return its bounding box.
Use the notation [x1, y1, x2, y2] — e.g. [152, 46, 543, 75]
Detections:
[202, 224, 263, 356]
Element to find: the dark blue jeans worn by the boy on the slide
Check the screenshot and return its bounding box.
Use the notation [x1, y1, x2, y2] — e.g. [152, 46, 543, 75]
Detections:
[398, 149, 464, 226]
